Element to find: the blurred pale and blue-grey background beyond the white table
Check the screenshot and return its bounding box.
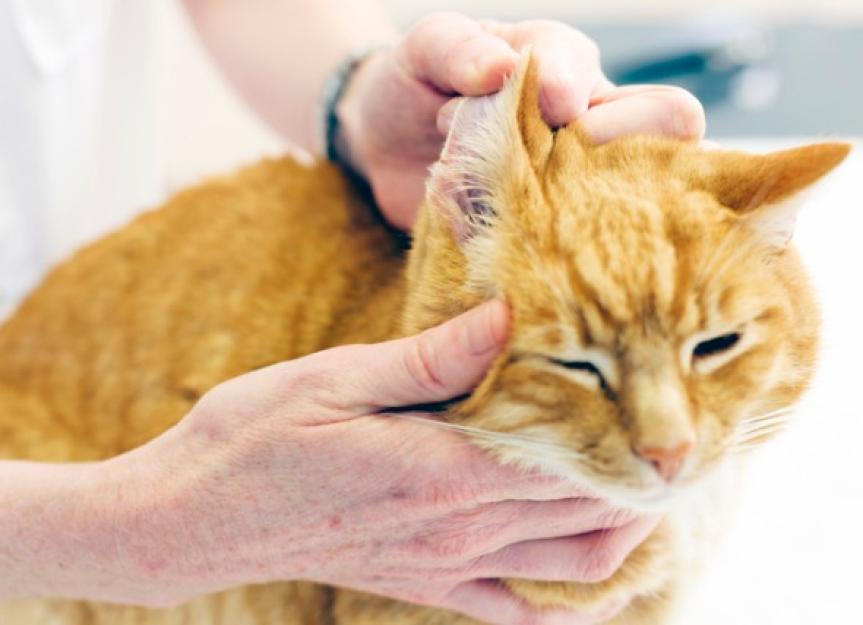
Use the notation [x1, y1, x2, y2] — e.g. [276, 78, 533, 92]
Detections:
[153, 0, 863, 186]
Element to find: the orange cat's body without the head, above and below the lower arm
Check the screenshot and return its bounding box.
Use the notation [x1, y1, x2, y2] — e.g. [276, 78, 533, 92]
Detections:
[0, 159, 690, 625]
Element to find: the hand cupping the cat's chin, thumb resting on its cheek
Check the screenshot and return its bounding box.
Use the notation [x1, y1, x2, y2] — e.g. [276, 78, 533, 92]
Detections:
[98, 302, 656, 624]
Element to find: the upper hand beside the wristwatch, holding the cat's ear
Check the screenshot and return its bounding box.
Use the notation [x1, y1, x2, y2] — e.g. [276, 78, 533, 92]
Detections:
[338, 13, 704, 229]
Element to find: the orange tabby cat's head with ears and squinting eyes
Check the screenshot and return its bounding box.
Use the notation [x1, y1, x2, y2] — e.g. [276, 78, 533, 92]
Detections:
[405, 60, 848, 507]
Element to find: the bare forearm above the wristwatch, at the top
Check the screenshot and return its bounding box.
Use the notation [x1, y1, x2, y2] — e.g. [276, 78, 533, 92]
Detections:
[183, 0, 396, 152]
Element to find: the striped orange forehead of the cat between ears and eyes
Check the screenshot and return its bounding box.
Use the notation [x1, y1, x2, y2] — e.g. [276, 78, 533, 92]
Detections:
[502, 176, 760, 344]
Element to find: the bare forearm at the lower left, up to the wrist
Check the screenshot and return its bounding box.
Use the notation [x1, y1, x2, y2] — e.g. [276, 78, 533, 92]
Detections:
[0, 440, 202, 607]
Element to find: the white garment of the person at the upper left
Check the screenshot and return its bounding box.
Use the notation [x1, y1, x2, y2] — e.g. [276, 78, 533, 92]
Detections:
[0, 0, 164, 315]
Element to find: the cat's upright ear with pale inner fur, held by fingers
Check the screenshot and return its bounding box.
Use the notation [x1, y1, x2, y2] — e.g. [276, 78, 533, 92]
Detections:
[428, 52, 553, 241]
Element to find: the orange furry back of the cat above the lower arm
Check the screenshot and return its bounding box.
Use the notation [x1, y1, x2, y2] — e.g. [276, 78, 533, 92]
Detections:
[0, 158, 401, 458]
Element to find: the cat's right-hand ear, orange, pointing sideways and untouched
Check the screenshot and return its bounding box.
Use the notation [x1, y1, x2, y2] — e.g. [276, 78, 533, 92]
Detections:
[693, 142, 851, 247]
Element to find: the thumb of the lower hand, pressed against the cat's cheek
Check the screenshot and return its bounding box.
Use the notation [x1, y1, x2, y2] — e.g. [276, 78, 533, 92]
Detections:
[330, 300, 509, 414]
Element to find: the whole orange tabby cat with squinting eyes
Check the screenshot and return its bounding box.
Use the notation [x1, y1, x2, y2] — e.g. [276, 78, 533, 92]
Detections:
[0, 56, 848, 625]
